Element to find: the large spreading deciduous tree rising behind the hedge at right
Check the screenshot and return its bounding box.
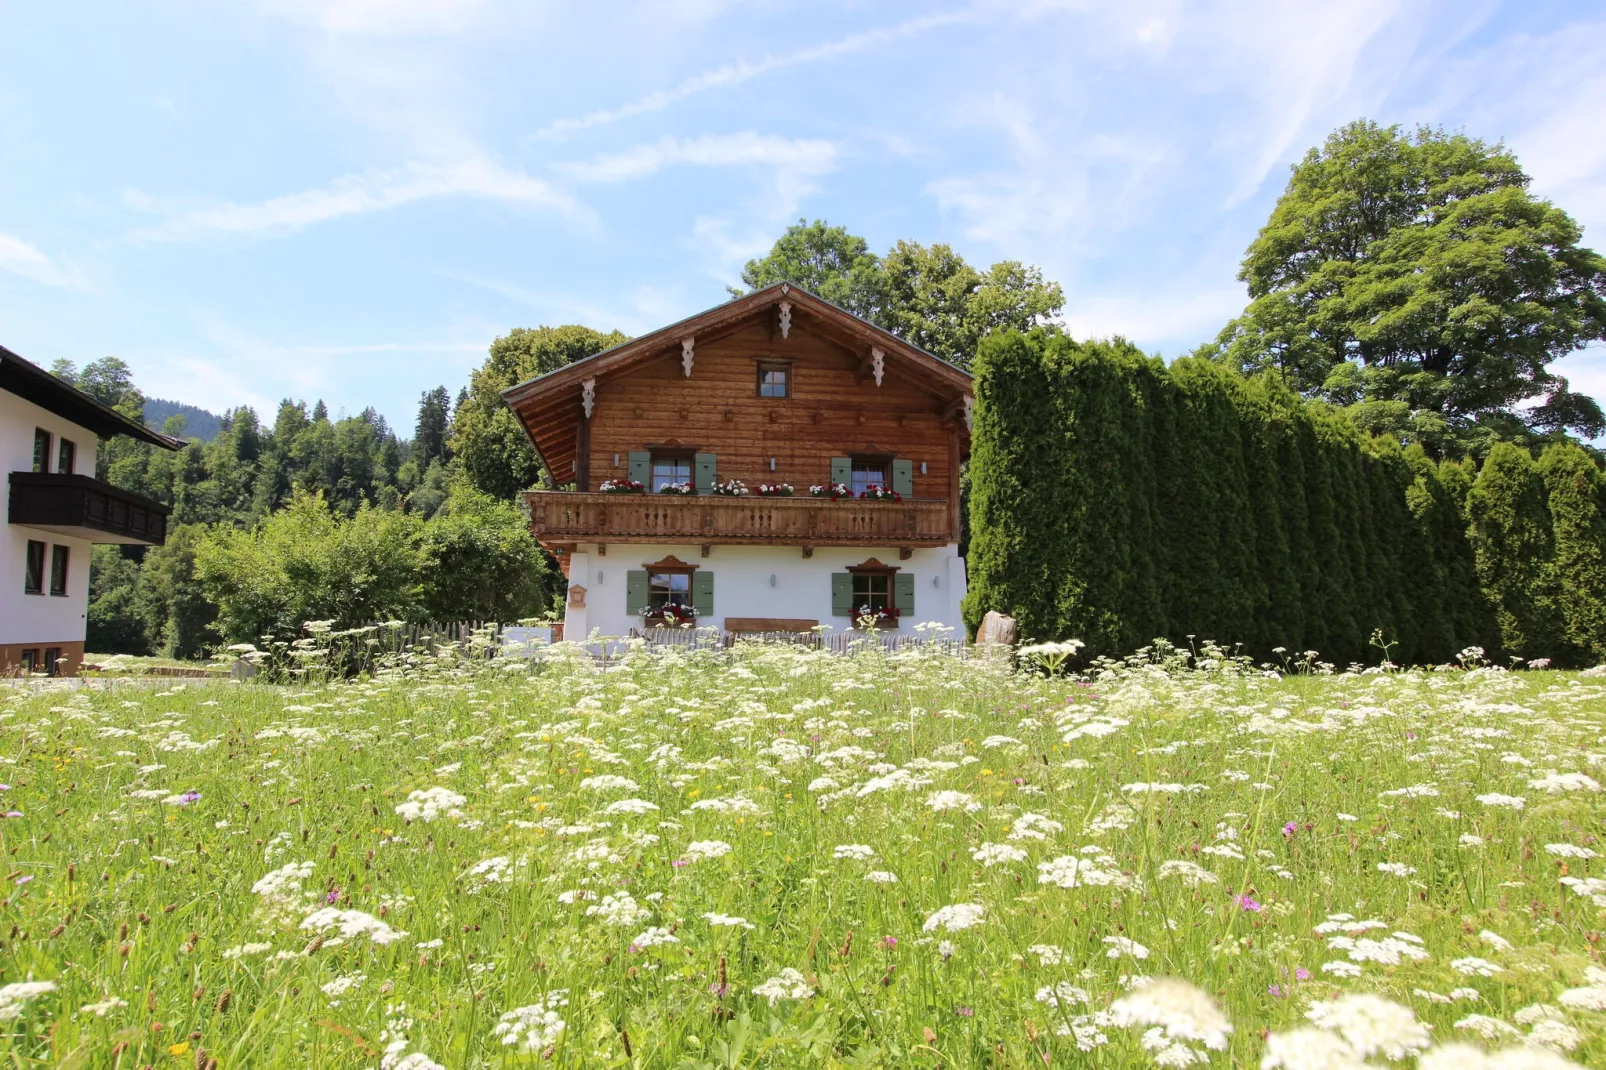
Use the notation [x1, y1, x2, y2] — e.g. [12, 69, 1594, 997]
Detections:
[1211, 120, 1606, 442]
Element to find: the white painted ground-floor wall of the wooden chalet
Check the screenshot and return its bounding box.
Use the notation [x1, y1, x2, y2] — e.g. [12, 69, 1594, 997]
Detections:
[564, 543, 965, 639]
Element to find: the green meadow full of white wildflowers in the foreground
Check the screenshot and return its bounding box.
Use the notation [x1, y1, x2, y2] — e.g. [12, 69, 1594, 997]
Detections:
[0, 646, 1606, 1070]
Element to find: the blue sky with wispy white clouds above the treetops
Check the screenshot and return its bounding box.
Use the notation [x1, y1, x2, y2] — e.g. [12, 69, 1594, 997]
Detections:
[0, 0, 1606, 432]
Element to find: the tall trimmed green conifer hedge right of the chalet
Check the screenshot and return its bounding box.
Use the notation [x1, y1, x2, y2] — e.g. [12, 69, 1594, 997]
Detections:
[965, 331, 1606, 665]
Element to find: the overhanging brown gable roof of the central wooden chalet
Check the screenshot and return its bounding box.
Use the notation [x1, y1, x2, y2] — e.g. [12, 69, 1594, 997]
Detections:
[503, 283, 972, 474]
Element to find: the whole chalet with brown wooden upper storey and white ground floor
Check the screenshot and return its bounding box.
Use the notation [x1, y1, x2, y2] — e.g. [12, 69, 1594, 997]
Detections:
[504, 284, 972, 638]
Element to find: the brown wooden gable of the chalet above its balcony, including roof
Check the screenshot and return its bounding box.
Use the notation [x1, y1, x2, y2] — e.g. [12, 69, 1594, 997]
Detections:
[503, 286, 972, 498]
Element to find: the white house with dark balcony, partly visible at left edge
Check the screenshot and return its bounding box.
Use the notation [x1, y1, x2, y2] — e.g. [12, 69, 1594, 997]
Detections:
[0, 347, 185, 676]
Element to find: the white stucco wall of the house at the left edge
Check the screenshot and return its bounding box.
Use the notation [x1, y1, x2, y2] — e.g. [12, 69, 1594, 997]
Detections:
[0, 390, 96, 644]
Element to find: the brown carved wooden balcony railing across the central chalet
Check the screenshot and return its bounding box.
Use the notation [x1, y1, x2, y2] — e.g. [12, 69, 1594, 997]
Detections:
[525, 490, 957, 546]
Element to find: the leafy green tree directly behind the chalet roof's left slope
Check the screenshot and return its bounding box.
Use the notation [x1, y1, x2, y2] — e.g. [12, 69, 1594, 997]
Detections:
[450, 325, 630, 500]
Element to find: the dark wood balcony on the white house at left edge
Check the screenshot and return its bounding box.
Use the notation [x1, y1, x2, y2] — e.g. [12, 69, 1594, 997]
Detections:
[8, 472, 172, 546]
